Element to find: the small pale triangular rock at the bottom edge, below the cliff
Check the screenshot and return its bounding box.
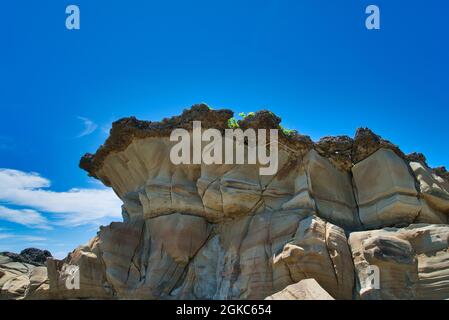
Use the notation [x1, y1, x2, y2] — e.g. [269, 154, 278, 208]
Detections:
[265, 279, 334, 300]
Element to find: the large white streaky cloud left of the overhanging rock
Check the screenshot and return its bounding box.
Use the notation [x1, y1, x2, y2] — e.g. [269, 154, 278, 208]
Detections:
[0, 168, 121, 226]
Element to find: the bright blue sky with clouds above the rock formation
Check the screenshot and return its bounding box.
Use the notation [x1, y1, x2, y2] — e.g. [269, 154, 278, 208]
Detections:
[0, 0, 449, 257]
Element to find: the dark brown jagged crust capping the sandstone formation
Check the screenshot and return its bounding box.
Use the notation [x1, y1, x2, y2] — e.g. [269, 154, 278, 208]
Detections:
[79, 104, 449, 184]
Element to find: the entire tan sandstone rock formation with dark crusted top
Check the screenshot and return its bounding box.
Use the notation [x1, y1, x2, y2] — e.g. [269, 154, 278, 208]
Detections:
[3, 105, 449, 299]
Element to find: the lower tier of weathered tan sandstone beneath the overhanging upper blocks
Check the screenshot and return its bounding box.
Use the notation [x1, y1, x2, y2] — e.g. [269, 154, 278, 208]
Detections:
[45, 211, 353, 299]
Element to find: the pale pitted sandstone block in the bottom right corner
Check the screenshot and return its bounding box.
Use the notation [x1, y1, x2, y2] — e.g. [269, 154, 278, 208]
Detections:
[349, 224, 449, 299]
